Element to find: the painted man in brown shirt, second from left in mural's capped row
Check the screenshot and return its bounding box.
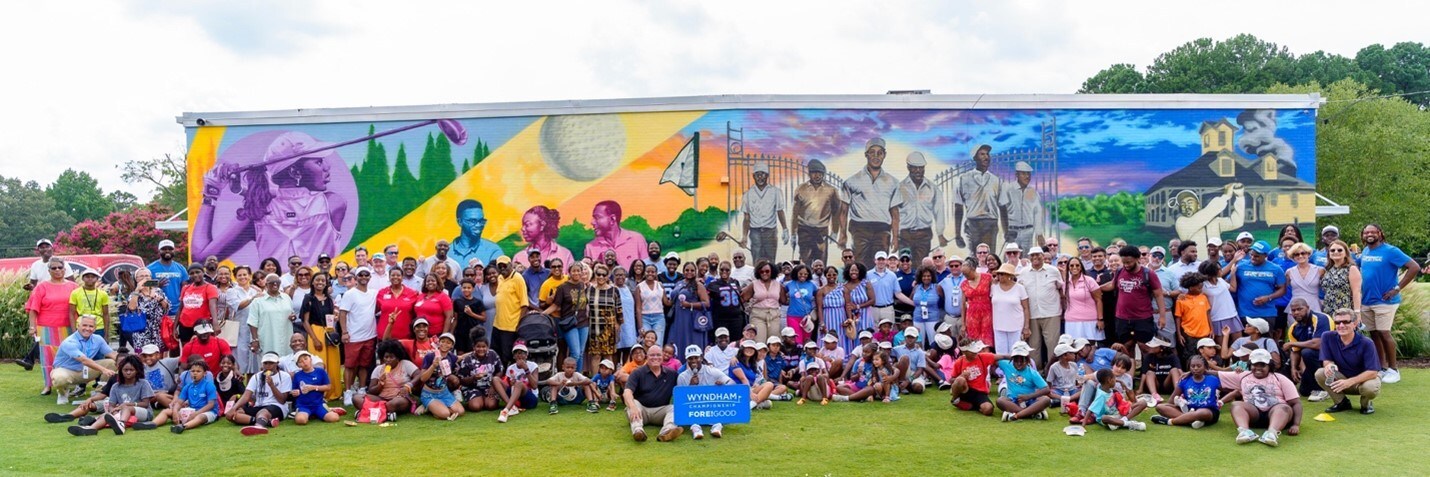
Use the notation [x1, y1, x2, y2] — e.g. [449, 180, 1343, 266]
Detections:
[791, 159, 844, 263]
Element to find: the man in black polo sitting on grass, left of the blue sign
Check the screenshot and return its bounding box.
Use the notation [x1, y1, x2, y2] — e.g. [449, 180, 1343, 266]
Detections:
[622, 346, 684, 443]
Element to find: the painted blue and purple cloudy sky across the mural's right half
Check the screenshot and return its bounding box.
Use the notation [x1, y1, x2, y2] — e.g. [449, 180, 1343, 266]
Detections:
[688, 110, 1316, 196]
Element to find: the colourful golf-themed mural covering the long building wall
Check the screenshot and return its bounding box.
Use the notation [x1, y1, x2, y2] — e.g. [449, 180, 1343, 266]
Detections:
[189, 110, 1316, 266]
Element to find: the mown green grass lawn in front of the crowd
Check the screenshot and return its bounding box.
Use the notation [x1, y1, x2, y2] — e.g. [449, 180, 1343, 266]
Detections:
[0, 364, 1430, 476]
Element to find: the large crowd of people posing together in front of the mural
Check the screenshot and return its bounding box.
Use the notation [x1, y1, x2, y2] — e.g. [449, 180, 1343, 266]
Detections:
[21, 224, 1420, 446]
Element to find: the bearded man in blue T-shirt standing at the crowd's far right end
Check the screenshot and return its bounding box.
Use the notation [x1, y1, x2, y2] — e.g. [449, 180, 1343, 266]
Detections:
[1357, 224, 1420, 384]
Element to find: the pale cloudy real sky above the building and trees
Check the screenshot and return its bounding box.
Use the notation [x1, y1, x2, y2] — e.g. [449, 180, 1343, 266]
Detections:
[0, 0, 1430, 197]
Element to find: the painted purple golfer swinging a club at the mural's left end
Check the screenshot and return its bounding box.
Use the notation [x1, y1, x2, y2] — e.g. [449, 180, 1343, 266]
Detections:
[193, 120, 466, 263]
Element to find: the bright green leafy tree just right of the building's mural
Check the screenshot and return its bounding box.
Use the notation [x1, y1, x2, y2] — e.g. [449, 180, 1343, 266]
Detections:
[1267, 80, 1430, 257]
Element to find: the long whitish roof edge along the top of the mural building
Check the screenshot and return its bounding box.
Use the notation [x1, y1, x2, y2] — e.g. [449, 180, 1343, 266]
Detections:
[174, 93, 1324, 127]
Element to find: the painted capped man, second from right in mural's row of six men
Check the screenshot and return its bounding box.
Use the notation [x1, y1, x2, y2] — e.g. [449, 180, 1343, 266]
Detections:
[954, 144, 1002, 248]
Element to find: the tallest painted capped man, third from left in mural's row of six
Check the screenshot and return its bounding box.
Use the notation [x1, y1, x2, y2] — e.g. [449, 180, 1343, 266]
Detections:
[839, 137, 899, 267]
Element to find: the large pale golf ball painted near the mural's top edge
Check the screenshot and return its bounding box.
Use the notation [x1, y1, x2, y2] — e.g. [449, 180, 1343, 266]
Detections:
[541, 114, 625, 181]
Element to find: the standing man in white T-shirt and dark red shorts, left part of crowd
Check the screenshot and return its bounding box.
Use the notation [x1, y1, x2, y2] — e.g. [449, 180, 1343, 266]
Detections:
[337, 267, 378, 406]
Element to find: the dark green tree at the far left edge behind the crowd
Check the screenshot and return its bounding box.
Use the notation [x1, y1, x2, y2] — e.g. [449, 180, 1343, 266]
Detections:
[0, 176, 76, 257]
